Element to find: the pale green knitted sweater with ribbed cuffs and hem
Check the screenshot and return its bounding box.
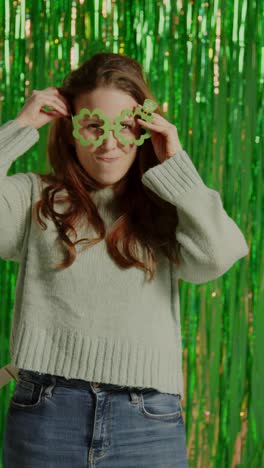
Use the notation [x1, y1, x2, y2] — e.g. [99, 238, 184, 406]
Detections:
[0, 120, 249, 397]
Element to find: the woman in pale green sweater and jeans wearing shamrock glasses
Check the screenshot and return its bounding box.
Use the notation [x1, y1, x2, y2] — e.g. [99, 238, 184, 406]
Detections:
[0, 53, 248, 468]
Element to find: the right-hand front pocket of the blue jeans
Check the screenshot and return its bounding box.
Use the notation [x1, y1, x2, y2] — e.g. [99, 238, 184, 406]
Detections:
[140, 390, 183, 423]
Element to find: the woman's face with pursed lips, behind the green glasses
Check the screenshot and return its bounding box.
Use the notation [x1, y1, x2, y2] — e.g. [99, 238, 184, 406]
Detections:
[74, 88, 138, 187]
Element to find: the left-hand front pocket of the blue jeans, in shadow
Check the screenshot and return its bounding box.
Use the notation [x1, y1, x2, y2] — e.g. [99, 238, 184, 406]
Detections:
[10, 377, 46, 409]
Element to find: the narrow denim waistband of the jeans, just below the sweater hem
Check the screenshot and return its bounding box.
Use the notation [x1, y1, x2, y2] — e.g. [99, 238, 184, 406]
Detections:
[18, 369, 155, 391]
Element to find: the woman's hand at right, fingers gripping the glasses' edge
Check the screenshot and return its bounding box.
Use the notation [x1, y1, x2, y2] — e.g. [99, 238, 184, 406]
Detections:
[137, 105, 182, 163]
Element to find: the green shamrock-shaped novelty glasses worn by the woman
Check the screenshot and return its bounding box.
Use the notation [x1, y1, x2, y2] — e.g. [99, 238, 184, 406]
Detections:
[72, 99, 158, 146]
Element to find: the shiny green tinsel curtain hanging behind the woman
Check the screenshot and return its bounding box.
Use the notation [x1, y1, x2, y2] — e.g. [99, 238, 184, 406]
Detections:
[0, 0, 264, 468]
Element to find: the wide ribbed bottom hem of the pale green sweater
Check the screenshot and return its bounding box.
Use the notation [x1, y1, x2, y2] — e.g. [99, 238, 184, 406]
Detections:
[11, 322, 183, 398]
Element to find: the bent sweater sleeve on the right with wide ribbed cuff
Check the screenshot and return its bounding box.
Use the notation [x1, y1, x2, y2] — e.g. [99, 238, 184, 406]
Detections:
[142, 150, 249, 284]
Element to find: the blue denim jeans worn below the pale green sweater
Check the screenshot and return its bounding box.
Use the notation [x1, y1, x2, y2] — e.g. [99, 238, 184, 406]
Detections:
[3, 369, 188, 468]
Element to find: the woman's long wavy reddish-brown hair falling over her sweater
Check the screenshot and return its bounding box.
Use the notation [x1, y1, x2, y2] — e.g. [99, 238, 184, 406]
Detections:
[33, 52, 182, 281]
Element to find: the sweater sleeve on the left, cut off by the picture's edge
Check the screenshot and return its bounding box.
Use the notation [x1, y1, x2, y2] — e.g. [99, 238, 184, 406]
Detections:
[0, 120, 39, 263]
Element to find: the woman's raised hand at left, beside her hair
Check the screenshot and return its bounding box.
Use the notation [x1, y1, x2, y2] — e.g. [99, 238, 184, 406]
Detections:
[15, 86, 70, 129]
